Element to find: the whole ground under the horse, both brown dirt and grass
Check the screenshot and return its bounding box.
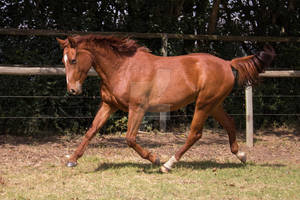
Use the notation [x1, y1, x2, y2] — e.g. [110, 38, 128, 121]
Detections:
[0, 129, 300, 200]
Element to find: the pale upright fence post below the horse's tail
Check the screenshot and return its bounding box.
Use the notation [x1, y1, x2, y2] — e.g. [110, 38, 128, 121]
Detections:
[245, 86, 253, 147]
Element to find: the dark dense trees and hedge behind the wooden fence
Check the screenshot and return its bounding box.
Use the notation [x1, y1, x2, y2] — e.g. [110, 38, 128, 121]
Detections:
[0, 0, 300, 135]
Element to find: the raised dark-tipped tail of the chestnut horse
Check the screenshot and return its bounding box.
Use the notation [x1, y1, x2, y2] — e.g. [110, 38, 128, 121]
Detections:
[230, 45, 276, 86]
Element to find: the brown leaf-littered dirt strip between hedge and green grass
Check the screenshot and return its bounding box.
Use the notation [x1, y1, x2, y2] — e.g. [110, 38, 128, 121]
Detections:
[0, 130, 300, 169]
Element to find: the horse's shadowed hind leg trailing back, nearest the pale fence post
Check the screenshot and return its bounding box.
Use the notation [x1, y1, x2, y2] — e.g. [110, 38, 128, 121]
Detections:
[213, 106, 246, 163]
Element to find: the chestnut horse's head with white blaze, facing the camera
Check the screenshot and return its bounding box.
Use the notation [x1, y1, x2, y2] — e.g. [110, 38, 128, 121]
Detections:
[56, 37, 93, 95]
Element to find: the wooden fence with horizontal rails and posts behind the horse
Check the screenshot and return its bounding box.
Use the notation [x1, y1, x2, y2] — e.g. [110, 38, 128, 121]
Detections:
[0, 28, 300, 147]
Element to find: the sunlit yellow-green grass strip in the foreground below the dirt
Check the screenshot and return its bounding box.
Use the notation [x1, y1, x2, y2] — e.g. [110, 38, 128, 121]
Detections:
[0, 156, 300, 200]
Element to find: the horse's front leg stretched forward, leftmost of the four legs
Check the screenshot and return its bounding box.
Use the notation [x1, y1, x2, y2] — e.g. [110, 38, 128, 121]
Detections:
[67, 102, 117, 167]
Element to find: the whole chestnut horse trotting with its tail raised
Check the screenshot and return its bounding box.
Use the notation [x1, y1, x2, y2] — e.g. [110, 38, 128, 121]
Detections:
[57, 35, 275, 172]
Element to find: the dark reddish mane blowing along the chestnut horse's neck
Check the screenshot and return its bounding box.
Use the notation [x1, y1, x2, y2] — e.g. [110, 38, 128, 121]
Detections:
[74, 35, 150, 56]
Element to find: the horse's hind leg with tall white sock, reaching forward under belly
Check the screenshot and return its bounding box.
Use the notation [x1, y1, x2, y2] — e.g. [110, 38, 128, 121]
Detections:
[160, 106, 210, 173]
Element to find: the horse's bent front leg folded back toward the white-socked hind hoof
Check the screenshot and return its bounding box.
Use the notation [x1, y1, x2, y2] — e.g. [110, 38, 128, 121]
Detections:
[126, 106, 160, 165]
